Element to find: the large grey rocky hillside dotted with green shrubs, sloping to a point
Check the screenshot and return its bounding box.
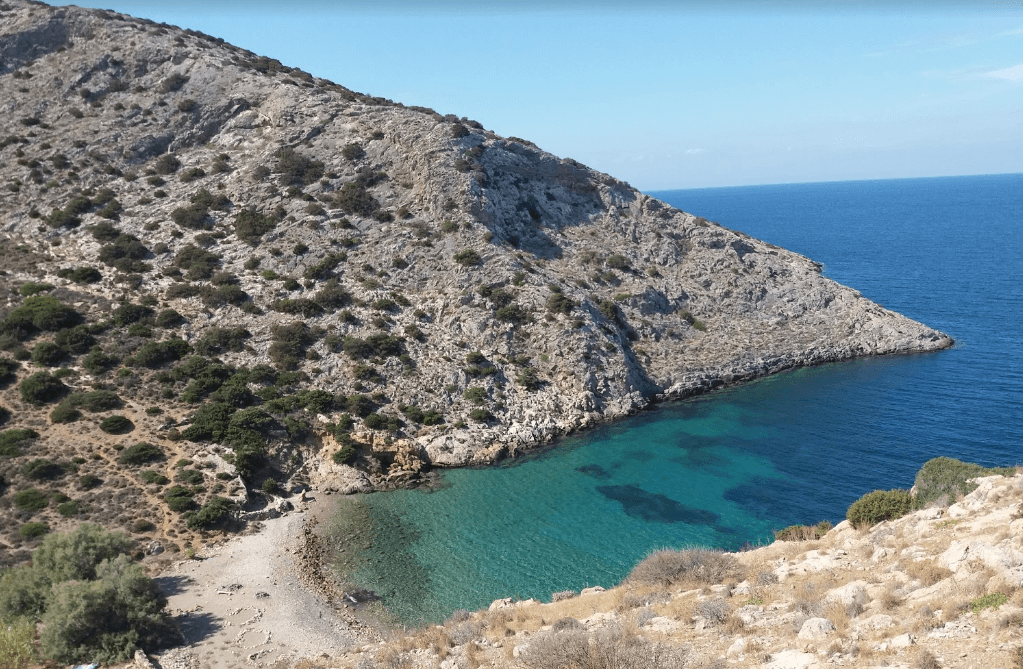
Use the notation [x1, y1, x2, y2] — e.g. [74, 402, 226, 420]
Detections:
[0, 0, 951, 561]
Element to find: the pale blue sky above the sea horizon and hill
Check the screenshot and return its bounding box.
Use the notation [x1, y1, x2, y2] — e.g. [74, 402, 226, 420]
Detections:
[51, 0, 1023, 191]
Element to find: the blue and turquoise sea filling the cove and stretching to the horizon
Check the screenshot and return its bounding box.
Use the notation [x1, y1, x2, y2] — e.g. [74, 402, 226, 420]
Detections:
[329, 174, 1023, 625]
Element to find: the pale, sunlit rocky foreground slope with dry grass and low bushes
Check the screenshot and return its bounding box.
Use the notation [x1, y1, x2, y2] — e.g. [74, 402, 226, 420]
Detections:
[313, 474, 1023, 669]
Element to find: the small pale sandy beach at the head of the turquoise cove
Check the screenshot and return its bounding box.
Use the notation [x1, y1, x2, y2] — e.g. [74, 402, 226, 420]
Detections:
[149, 496, 379, 669]
